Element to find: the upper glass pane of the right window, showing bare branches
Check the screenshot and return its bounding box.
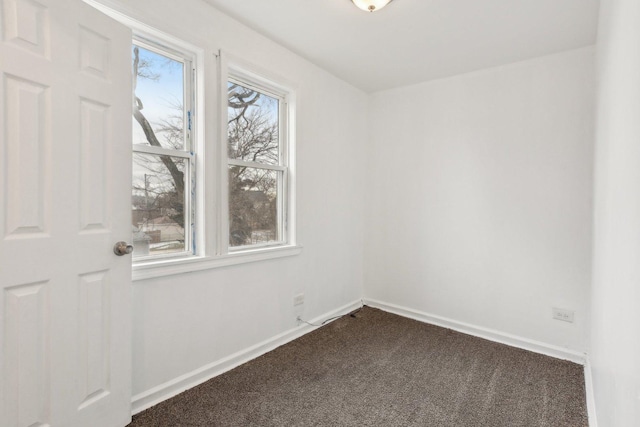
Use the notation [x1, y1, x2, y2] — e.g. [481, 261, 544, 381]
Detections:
[227, 82, 280, 165]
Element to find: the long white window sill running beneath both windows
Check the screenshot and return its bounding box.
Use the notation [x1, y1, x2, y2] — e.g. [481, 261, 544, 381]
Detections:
[132, 246, 302, 281]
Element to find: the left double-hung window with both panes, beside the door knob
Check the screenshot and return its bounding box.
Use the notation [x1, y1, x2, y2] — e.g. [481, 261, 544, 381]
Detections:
[132, 40, 195, 261]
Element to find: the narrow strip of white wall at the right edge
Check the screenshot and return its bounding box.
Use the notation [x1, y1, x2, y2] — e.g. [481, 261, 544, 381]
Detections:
[590, 0, 640, 427]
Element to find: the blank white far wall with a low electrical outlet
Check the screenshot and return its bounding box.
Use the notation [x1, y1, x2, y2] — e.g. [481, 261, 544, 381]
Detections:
[364, 47, 594, 352]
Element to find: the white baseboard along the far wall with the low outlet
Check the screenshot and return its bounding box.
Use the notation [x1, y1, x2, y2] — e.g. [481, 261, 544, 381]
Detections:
[363, 298, 586, 365]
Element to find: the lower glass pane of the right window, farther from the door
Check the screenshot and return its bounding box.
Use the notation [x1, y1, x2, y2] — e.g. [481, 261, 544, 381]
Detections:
[229, 166, 280, 246]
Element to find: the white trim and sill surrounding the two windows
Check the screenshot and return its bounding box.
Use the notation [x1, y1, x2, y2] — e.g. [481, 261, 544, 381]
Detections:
[84, 0, 302, 281]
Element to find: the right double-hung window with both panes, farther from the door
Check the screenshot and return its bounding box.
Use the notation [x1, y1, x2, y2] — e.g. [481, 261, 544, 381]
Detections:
[227, 77, 289, 250]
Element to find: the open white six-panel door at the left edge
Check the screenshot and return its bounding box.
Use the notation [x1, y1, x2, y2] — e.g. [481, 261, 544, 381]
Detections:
[0, 0, 131, 427]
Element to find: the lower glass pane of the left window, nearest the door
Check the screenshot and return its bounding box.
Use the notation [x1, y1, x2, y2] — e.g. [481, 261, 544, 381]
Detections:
[132, 153, 187, 256]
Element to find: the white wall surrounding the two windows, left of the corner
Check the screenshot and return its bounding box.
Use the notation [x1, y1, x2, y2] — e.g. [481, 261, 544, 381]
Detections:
[103, 0, 367, 402]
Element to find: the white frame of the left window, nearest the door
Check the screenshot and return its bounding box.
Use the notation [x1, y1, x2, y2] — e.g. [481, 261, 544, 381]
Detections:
[131, 36, 201, 266]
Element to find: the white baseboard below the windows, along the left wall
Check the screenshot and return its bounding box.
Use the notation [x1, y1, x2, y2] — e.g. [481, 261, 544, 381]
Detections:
[131, 300, 362, 415]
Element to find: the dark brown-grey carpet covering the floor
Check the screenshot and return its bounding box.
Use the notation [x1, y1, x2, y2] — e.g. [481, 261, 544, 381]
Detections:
[130, 307, 588, 427]
